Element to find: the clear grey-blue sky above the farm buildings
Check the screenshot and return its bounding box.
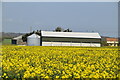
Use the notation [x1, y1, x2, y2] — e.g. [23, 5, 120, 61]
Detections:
[2, 2, 118, 37]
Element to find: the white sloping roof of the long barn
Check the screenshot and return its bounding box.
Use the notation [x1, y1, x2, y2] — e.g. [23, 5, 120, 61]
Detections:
[41, 31, 101, 38]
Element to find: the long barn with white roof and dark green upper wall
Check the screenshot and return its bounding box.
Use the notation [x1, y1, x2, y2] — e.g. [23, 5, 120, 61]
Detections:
[40, 31, 101, 47]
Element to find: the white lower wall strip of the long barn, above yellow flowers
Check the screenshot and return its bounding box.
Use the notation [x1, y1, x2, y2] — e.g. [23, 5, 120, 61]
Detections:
[42, 42, 101, 47]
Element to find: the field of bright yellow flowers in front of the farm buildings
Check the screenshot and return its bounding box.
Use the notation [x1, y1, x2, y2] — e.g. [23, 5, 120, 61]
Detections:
[1, 46, 120, 79]
